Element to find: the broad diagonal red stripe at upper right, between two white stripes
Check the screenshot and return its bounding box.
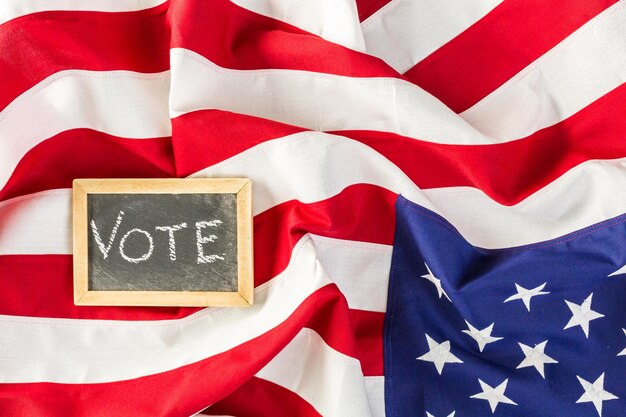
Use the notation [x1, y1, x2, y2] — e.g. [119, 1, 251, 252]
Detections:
[405, 0, 617, 112]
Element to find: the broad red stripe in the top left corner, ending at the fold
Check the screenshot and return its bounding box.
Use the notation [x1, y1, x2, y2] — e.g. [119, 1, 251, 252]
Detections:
[0, 3, 169, 109]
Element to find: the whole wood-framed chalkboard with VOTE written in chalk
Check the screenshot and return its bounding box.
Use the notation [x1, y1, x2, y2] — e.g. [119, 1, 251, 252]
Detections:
[73, 178, 253, 306]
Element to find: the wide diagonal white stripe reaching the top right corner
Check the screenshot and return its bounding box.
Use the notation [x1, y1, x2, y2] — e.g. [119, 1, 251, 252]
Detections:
[461, 1, 626, 140]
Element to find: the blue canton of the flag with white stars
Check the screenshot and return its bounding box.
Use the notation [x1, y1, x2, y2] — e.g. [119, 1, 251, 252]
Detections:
[384, 197, 626, 417]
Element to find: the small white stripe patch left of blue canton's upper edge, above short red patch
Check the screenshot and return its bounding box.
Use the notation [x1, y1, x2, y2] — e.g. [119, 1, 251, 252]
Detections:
[311, 235, 392, 313]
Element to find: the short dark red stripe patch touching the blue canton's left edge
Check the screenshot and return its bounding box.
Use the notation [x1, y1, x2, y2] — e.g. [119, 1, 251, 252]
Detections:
[350, 308, 387, 376]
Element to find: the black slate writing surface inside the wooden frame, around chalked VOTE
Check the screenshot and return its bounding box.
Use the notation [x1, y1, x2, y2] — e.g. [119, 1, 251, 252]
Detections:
[87, 194, 237, 291]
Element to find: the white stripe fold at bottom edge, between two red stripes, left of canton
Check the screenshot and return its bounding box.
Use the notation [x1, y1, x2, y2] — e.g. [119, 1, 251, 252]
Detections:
[256, 328, 371, 417]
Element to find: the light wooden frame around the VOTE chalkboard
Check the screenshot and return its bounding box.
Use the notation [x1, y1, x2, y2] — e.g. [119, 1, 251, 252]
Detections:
[72, 178, 254, 307]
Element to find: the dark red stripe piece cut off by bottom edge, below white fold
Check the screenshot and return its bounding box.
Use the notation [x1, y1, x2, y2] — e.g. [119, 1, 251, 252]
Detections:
[201, 377, 321, 417]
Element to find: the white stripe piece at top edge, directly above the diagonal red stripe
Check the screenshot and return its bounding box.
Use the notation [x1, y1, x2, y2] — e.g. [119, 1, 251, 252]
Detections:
[361, 0, 502, 73]
